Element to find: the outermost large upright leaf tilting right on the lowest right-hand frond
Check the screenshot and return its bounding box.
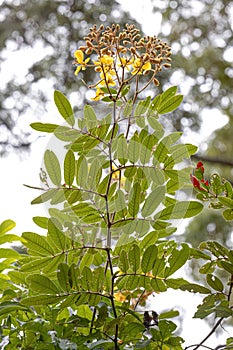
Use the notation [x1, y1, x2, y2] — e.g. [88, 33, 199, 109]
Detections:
[164, 243, 189, 277]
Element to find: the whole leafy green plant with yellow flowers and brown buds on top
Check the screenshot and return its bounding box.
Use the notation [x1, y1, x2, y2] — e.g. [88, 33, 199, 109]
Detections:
[0, 25, 233, 350]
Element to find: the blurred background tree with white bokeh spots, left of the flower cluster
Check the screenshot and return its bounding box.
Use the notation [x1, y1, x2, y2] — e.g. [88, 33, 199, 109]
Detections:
[0, 0, 140, 153]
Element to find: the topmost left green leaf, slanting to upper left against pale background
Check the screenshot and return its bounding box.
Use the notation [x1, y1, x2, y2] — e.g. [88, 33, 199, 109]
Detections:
[54, 90, 75, 126]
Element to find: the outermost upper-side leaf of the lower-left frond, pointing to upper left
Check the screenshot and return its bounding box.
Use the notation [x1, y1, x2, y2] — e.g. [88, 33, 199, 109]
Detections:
[22, 232, 54, 256]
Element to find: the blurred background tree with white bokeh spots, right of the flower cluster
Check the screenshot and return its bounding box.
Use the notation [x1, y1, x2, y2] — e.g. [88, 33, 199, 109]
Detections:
[151, 0, 233, 175]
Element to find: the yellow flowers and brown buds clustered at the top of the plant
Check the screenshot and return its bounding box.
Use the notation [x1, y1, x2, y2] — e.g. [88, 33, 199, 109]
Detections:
[74, 24, 171, 101]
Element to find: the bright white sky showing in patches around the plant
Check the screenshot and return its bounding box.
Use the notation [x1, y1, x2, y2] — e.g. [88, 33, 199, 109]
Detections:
[0, 0, 230, 346]
